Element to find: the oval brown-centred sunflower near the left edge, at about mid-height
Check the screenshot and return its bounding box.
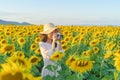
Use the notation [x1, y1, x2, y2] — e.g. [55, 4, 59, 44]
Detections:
[1, 44, 15, 54]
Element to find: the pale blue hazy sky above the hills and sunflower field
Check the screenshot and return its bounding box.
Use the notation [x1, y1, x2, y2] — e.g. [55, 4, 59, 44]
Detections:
[0, 0, 120, 25]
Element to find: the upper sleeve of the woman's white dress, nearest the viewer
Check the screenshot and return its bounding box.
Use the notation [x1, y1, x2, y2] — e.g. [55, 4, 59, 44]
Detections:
[39, 42, 53, 58]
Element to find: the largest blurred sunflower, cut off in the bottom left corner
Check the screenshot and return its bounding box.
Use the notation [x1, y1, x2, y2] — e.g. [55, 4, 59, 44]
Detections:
[0, 62, 23, 80]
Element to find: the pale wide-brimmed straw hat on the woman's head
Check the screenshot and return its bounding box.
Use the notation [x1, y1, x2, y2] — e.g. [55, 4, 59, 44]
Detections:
[39, 23, 59, 34]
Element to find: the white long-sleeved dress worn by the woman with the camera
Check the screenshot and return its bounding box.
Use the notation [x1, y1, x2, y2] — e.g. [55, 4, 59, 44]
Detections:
[39, 42, 64, 77]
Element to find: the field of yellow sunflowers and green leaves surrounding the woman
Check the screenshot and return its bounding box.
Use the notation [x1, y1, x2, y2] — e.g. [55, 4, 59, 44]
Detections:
[0, 25, 120, 80]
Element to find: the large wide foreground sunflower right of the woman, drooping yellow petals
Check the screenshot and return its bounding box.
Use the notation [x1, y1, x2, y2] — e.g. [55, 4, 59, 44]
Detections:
[69, 60, 93, 73]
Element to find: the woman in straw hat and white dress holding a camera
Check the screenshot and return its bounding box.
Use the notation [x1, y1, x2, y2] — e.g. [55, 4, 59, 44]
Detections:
[39, 23, 64, 77]
